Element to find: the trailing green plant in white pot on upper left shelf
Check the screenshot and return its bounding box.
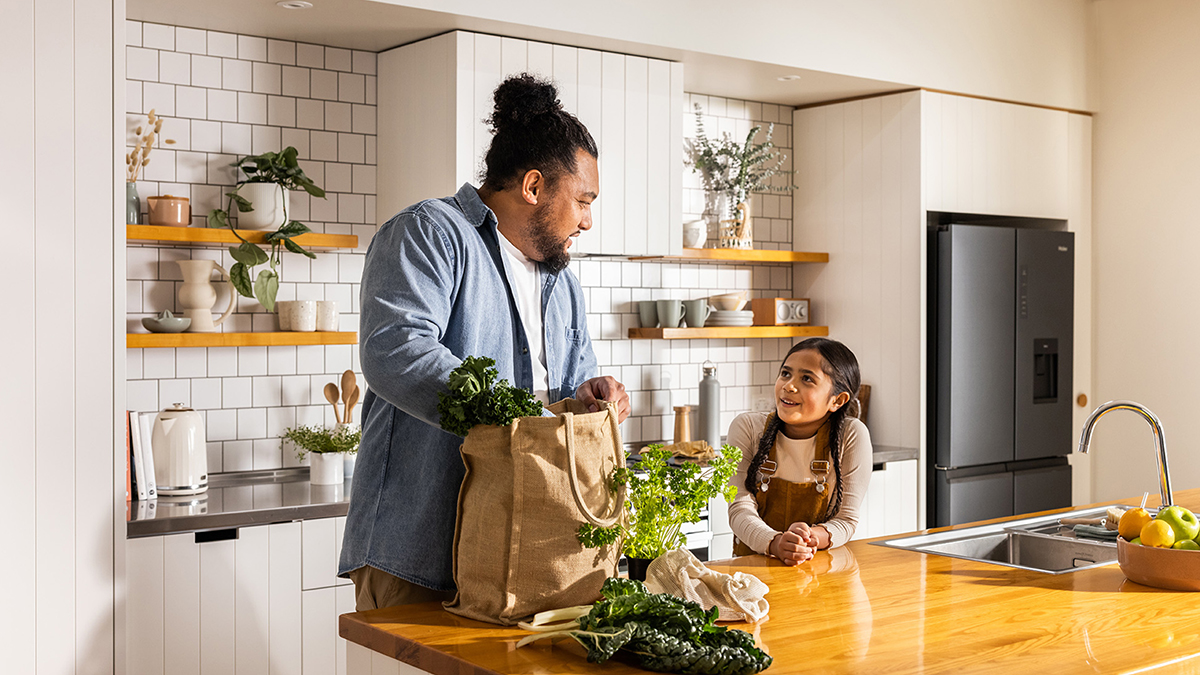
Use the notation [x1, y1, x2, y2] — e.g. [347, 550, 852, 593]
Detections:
[209, 145, 325, 312]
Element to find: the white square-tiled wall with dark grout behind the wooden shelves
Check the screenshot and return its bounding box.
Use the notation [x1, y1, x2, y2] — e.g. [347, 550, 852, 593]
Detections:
[126, 22, 792, 472]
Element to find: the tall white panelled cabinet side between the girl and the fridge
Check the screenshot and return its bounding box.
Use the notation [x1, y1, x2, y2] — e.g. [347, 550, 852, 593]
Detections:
[793, 92, 925, 526]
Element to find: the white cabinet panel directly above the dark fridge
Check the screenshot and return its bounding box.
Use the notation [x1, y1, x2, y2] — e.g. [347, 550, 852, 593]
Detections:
[922, 91, 1069, 219]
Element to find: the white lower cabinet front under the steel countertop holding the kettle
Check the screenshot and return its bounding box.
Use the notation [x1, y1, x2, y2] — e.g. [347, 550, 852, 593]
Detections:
[126, 519, 304, 675]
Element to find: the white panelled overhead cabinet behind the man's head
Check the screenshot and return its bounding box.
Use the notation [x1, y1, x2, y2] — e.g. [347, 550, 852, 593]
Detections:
[377, 31, 683, 256]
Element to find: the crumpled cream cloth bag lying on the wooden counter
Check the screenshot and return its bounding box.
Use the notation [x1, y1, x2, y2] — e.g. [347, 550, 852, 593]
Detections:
[646, 549, 770, 622]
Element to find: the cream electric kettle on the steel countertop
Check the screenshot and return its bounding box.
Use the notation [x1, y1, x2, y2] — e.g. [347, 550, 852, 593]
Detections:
[150, 404, 209, 496]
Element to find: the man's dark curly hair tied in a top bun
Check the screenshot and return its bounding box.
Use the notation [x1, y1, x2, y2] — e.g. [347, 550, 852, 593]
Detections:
[484, 73, 599, 190]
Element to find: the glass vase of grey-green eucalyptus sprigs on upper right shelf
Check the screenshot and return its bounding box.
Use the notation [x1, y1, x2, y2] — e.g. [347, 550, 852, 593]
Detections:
[690, 103, 796, 249]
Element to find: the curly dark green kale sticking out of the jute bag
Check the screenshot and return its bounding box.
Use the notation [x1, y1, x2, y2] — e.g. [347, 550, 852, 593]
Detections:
[438, 357, 542, 436]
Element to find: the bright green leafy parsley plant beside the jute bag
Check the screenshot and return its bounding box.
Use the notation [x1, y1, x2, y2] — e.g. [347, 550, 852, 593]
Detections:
[577, 444, 742, 580]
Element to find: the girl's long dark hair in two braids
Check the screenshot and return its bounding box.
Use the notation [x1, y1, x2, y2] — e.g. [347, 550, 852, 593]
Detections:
[745, 338, 860, 520]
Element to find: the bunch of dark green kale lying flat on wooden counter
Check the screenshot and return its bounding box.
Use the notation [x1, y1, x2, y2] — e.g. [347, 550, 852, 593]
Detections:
[517, 571, 772, 675]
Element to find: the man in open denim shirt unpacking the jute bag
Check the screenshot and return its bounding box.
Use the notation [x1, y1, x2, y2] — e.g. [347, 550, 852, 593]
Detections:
[338, 74, 629, 611]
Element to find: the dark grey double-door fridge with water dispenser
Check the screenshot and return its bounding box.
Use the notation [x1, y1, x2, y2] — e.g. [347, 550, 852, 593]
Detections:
[928, 225, 1075, 527]
